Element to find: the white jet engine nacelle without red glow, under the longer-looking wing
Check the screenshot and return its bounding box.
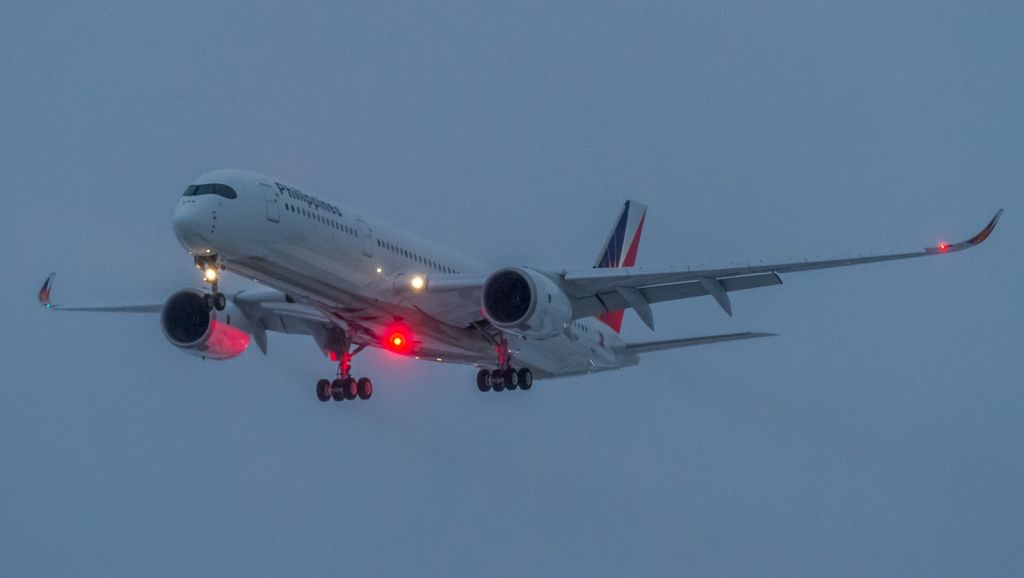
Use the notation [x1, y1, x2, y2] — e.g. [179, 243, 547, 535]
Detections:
[483, 266, 572, 339]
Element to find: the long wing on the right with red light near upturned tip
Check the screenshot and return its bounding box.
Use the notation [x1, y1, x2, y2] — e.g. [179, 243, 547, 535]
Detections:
[561, 209, 1002, 329]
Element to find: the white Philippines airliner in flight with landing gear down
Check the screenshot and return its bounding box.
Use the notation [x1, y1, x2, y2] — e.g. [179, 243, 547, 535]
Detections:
[39, 169, 1002, 402]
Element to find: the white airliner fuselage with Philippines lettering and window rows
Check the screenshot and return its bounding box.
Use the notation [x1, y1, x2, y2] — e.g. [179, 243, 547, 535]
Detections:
[173, 170, 636, 377]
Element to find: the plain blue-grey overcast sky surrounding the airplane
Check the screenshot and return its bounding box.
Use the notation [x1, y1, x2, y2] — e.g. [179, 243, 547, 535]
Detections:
[0, 1, 1024, 576]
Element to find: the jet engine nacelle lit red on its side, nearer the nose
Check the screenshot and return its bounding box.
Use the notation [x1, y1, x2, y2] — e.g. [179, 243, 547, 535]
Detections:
[160, 289, 252, 360]
